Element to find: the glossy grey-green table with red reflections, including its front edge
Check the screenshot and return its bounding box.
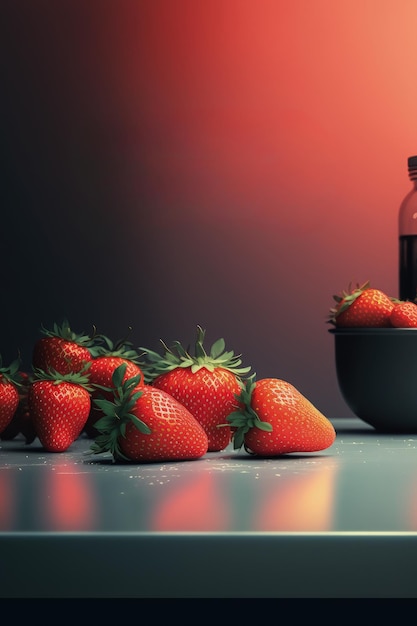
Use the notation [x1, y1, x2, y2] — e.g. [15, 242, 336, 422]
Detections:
[0, 418, 417, 597]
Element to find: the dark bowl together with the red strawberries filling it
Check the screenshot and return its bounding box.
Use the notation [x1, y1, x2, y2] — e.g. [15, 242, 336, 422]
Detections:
[328, 282, 417, 433]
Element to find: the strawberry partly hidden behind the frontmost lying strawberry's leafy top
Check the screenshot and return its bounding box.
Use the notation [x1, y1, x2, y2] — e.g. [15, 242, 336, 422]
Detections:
[84, 335, 144, 437]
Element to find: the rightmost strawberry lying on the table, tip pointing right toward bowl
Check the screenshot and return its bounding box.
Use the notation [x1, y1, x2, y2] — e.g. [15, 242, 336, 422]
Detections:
[228, 376, 336, 456]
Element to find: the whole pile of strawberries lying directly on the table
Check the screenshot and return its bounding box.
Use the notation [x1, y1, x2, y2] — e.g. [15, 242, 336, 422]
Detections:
[0, 321, 336, 462]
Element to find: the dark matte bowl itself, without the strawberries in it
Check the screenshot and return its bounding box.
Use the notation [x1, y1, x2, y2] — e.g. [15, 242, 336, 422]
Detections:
[329, 328, 417, 433]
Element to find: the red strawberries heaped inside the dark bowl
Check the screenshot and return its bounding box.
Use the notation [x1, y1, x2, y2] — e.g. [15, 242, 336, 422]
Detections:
[327, 281, 417, 328]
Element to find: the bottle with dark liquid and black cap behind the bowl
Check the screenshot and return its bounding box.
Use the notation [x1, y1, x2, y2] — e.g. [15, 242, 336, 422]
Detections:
[398, 156, 417, 300]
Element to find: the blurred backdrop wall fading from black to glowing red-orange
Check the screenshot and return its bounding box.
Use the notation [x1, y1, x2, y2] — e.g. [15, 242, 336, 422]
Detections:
[0, 0, 417, 417]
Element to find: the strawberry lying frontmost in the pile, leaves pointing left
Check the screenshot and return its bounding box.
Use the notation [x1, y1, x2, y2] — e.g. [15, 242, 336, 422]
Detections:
[90, 363, 208, 462]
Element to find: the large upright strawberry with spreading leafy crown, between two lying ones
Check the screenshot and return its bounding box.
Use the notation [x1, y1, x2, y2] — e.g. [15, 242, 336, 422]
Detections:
[142, 326, 250, 452]
